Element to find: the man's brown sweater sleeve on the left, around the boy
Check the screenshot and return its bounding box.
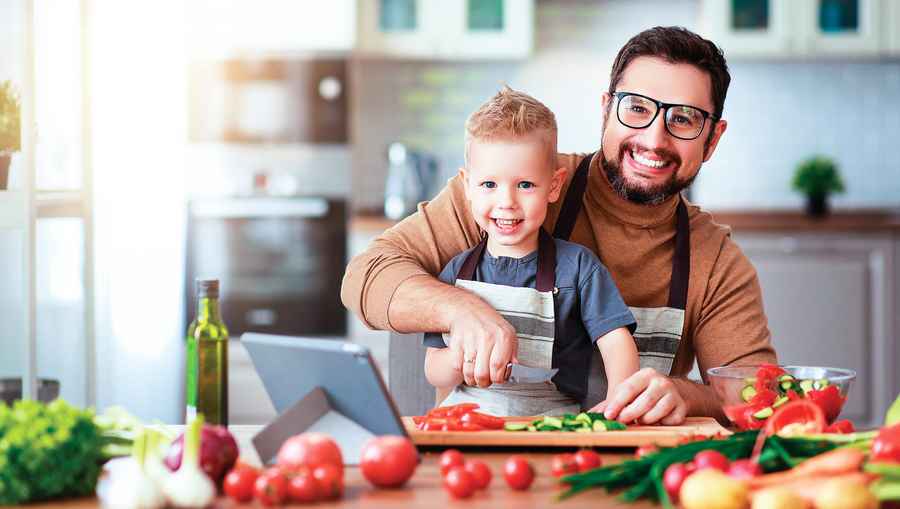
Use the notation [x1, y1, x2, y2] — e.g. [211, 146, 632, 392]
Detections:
[341, 174, 480, 330]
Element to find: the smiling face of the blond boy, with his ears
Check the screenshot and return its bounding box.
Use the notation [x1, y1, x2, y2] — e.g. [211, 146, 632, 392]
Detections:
[460, 139, 565, 258]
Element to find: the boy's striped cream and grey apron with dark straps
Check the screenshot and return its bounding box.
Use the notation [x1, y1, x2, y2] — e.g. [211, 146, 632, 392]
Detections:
[441, 229, 580, 415]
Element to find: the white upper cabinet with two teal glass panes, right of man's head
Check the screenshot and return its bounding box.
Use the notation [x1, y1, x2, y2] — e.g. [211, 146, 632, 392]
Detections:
[701, 0, 900, 57]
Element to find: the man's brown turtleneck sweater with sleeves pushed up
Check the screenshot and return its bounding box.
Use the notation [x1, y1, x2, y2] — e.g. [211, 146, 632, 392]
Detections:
[341, 154, 776, 380]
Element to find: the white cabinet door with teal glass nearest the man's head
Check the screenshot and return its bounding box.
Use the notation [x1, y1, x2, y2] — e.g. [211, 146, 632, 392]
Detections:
[701, 0, 802, 57]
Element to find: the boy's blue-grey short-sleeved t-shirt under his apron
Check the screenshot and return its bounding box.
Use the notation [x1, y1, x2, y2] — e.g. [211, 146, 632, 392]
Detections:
[423, 239, 636, 401]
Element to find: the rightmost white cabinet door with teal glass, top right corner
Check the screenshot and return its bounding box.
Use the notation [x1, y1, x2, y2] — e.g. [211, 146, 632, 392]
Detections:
[795, 0, 880, 56]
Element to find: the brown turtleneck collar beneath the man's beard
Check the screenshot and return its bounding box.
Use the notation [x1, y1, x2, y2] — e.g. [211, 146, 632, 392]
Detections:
[585, 150, 680, 228]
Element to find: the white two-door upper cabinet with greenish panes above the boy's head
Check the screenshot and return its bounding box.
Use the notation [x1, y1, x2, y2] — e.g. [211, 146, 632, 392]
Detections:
[357, 0, 534, 60]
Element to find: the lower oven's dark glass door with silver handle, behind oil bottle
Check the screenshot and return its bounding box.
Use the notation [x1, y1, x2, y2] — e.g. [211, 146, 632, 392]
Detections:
[185, 197, 347, 338]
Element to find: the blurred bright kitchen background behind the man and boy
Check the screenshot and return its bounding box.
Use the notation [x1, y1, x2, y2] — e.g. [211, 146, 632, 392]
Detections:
[0, 0, 900, 425]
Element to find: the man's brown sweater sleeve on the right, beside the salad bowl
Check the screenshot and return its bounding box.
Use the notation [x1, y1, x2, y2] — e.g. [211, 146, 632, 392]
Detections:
[693, 232, 777, 380]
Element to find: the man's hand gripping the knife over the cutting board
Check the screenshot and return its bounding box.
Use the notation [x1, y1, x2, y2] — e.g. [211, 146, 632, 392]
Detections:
[450, 297, 518, 387]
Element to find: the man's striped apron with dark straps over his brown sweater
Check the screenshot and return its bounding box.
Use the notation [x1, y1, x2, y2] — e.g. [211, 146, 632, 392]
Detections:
[553, 154, 691, 408]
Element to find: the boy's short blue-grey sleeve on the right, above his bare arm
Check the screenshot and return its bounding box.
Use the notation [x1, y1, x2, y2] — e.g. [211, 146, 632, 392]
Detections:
[578, 257, 637, 342]
